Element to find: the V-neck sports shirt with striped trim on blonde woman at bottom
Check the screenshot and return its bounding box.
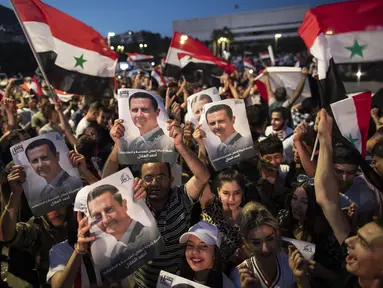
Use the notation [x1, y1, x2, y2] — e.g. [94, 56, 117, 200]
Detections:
[230, 253, 295, 288]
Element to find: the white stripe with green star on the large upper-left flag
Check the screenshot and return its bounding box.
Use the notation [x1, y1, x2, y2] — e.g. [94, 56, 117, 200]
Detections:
[24, 22, 117, 77]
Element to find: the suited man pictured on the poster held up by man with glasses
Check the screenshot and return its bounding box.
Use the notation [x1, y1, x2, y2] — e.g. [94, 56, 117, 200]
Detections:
[121, 92, 173, 151]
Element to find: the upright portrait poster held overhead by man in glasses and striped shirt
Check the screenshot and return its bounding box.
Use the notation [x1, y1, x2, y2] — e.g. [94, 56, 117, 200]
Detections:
[118, 88, 177, 165]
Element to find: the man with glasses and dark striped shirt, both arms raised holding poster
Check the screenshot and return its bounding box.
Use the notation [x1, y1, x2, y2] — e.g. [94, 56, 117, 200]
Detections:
[102, 120, 210, 288]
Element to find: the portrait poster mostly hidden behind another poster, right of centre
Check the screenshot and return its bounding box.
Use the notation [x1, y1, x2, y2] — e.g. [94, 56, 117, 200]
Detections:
[185, 87, 221, 126]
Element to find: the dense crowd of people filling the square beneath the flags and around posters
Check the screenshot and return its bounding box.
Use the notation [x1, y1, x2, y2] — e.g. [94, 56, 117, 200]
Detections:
[0, 59, 383, 288]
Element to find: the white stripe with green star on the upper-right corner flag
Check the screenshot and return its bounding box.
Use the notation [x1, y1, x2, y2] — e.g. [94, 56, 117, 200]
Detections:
[326, 31, 383, 64]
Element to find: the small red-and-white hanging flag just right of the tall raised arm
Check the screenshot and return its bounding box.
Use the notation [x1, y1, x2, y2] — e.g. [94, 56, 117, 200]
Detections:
[330, 92, 372, 157]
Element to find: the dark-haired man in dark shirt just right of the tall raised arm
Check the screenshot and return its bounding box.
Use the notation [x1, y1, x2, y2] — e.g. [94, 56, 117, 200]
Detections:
[333, 144, 377, 226]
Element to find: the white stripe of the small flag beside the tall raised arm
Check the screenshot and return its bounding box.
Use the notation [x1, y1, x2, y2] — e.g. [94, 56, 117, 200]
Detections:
[330, 98, 362, 153]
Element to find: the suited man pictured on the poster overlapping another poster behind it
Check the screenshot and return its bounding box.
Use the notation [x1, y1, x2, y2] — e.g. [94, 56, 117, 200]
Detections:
[206, 104, 252, 158]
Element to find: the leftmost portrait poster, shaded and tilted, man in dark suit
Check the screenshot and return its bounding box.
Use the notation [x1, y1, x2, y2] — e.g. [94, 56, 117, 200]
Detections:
[10, 132, 83, 216]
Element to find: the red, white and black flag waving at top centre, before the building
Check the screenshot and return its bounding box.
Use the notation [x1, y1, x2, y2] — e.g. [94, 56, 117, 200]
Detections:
[163, 31, 215, 78]
